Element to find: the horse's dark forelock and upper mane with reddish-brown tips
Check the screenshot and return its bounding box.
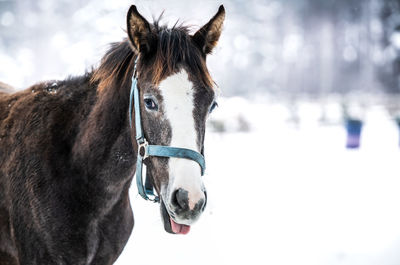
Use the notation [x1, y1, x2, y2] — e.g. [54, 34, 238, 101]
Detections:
[91, 17, 214, 91]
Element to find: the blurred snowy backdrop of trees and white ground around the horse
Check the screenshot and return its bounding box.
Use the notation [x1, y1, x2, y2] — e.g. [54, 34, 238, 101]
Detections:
[0, 0, 400, 265]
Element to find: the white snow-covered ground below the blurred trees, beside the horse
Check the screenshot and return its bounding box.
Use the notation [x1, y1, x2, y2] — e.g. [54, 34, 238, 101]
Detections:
[117, 99, 400, 265]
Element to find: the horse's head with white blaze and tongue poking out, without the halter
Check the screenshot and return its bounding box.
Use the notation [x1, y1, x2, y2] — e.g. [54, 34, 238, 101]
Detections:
[127, 6, 225, 234]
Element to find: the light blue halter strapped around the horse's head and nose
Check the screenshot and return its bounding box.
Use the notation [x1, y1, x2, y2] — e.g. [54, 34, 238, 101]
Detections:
[129, 58, 206, 202]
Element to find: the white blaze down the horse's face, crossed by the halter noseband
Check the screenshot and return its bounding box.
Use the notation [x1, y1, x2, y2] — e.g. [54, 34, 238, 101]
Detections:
[160, 70, 204, 212]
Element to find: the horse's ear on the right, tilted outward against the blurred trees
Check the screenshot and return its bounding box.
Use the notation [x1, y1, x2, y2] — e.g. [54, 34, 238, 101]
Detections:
[193, 5, 225, 54]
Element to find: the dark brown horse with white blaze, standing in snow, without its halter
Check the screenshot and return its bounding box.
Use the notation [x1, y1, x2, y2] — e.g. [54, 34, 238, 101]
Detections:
[0, 5, 225, 265]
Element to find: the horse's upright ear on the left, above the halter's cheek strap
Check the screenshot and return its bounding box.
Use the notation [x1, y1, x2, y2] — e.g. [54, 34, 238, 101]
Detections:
[126, 5, 151, 52]
